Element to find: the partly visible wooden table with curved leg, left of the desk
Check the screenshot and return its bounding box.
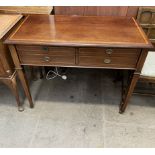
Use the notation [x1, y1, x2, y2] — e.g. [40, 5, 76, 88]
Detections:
[0, 14, 23, 111]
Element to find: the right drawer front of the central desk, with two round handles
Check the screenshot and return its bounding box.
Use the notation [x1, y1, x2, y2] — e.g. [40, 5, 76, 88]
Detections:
[79, 48, 140, 69]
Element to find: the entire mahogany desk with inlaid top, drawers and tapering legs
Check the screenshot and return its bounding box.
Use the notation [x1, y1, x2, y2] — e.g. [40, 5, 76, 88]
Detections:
[5, 15, 152, 113]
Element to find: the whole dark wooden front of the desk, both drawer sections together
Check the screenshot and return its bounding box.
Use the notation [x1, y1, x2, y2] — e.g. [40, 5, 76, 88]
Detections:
[16, 45, 140, 69]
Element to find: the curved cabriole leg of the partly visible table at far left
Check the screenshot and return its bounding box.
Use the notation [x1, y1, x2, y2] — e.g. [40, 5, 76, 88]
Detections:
[1, 73, 24, 112]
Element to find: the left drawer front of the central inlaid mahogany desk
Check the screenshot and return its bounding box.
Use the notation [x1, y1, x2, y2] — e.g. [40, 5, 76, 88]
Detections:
[16, 45, 75, 66]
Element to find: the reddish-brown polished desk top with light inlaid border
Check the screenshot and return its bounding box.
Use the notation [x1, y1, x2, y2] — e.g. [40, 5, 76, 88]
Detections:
[6, 15, 152, 48]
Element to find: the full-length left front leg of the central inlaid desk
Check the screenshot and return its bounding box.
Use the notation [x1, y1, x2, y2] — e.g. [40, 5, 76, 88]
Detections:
[9, 45, 34, 108]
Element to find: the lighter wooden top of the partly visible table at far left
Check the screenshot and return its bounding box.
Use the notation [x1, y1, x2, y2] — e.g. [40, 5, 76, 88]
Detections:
[0, 14, 22, 39]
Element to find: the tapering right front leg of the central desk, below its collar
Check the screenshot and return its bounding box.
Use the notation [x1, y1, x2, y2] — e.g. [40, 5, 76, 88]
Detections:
[119, 73, 140, 113]
